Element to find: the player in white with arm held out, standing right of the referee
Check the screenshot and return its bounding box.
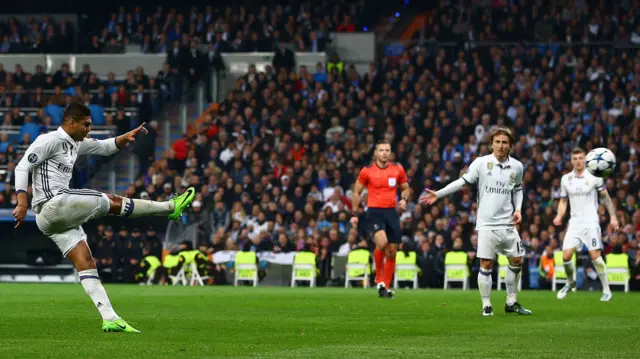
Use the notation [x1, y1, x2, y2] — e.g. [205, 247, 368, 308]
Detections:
[420, 128, 531, 316]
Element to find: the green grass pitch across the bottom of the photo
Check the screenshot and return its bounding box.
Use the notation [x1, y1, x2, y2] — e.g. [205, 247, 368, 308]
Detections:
[0, 284, 640, 359]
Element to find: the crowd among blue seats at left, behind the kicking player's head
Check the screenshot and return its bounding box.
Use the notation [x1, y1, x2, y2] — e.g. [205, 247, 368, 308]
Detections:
[0, 58, 168, 191]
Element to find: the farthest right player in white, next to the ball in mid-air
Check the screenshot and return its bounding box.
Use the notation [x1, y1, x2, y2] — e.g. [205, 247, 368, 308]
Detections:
[553, 148, 619, 302]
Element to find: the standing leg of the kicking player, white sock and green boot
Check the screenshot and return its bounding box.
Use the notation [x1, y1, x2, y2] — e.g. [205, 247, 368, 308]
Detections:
[65, 239, 140, 333]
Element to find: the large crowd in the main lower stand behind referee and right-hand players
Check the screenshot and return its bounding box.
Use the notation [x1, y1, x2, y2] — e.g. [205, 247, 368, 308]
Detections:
[3, 1, 640, 288]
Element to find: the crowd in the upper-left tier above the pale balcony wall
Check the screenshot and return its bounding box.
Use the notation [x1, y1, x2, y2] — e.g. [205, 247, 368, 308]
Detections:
[0, 0, 376, 53]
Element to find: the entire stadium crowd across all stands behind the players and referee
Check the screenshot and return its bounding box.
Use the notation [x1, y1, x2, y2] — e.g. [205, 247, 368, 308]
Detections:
[0, 0, 640, 288]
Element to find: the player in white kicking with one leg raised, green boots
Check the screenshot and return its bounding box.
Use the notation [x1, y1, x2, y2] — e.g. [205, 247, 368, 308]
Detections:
[13, 102, 195, 333]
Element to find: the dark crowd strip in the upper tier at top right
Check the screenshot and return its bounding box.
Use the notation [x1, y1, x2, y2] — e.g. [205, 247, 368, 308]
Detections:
[416, 0, 640, 45]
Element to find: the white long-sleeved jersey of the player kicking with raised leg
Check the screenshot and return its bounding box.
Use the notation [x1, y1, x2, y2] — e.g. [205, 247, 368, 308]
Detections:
[15, 127, 118, 208]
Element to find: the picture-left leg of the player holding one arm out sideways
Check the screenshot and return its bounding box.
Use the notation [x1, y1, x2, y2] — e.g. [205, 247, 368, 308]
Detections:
[477, 229, 497, 317]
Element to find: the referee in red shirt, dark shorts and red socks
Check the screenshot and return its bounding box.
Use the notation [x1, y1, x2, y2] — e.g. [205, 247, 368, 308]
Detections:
[351, 141, 411, 298]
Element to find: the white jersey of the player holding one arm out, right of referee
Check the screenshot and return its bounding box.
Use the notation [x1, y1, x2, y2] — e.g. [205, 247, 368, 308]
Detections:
[462, 154, 523, 229]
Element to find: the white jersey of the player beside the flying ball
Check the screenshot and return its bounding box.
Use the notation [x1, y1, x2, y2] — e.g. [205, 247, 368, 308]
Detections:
[560, 170, 604, 228]
